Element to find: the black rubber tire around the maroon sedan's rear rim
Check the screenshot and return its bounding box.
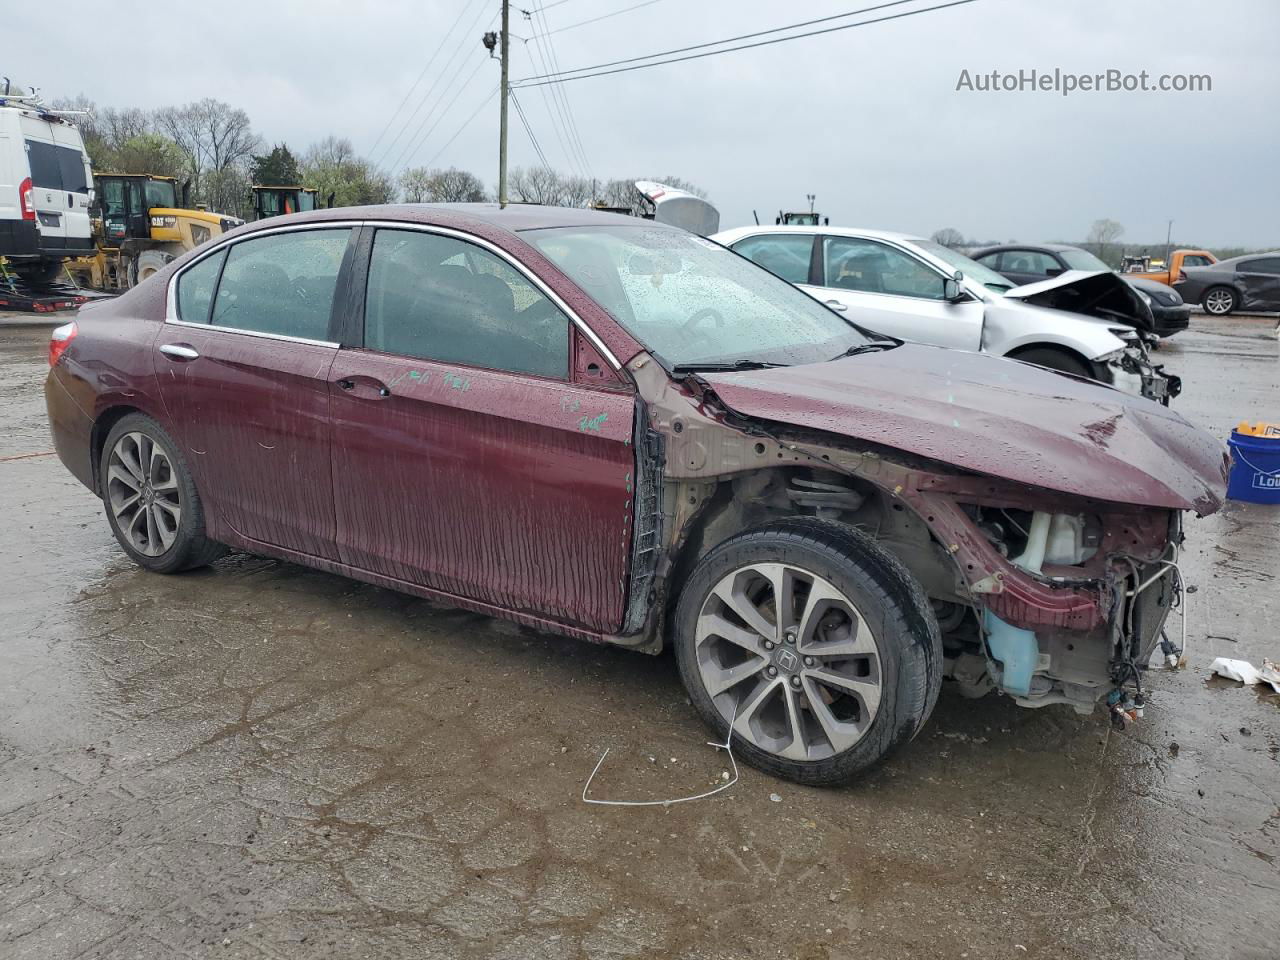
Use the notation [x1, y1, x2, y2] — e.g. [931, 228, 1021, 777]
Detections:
[99, 413, 227, 573]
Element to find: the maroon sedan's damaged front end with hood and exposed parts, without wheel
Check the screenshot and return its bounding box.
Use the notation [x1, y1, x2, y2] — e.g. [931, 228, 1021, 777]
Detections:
[641, 344, 1229, 722]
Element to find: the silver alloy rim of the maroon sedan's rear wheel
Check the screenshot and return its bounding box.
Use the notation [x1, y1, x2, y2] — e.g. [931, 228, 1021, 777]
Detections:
[106, 433, 182, 557]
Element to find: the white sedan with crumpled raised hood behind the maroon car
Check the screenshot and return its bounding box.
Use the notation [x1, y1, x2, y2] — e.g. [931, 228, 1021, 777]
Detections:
[712, 227, 1180, 402]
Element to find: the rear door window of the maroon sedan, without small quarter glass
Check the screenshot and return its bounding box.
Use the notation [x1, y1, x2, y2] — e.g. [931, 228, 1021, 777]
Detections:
[208, 228, 351, 340]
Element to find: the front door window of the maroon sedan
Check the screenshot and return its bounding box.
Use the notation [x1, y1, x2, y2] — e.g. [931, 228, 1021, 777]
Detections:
[365, 230, 570, 379]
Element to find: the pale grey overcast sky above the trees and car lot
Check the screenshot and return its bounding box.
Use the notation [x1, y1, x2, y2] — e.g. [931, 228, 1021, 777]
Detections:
[12, 0, 1280, 247]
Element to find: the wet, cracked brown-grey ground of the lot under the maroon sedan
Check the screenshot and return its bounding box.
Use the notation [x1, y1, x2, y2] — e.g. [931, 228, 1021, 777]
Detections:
[0, 316, 1280, 960]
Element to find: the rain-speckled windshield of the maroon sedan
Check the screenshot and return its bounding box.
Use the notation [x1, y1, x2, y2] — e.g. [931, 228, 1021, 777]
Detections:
[521, 224, 874, 367]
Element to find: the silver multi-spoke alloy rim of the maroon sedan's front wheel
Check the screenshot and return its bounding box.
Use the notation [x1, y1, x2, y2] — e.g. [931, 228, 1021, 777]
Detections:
[694, 563, 882, 760]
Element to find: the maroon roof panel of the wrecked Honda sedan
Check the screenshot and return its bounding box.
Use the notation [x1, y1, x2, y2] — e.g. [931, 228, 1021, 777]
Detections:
[235, 204, 675, 239]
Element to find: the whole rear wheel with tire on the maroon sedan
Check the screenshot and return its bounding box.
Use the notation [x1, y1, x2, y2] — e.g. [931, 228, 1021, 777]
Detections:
[99, 413, 224, 573]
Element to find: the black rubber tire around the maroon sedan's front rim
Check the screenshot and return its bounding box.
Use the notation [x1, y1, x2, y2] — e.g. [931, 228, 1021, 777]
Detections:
[672, 517, 942, 786]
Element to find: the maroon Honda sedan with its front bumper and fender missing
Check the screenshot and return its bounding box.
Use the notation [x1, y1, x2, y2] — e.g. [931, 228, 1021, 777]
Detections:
[46, 205, 1226, 783]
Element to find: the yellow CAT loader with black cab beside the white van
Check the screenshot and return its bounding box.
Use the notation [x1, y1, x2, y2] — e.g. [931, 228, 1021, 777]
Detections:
[67, 173, 244, 291]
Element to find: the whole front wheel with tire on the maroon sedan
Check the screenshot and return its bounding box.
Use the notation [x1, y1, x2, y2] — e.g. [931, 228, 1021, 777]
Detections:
[675, 517, 942, 785]
